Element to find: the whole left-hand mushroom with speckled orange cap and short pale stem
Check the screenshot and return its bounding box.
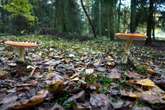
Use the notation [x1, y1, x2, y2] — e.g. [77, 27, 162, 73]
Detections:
[5, 41, 38, 62]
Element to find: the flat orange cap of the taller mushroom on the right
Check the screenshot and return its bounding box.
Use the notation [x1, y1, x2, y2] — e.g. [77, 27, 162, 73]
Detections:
[115, 33, 146, 40]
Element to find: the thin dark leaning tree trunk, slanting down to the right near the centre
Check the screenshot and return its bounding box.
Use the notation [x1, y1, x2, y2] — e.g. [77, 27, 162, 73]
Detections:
[80, 0, 97, 38]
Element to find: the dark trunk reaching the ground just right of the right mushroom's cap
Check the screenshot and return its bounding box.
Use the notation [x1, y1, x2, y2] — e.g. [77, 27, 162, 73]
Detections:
[145, 0, 154, 45]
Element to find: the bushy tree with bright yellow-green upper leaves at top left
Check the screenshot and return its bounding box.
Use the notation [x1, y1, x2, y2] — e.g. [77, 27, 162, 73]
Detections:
[3, 0, 37, 34]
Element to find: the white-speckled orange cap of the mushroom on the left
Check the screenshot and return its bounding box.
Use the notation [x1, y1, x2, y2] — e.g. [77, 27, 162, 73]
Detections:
[5, 41, 38, 48]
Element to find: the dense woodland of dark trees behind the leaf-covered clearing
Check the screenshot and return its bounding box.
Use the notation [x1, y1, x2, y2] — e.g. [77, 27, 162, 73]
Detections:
[0, 0, 165, 44]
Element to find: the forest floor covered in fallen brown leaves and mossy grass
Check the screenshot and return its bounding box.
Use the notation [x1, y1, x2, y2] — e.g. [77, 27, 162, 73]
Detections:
[0, 36, 165, 110]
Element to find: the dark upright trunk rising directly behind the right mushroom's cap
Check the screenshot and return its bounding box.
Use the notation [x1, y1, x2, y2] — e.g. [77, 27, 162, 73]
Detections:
[130, 0, 136, 33]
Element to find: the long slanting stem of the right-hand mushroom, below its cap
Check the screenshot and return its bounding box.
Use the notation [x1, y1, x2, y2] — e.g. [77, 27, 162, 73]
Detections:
[122, 40, 133, 64]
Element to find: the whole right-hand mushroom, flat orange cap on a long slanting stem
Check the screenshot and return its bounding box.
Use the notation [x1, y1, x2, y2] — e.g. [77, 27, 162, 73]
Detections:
[115, 33, 146, 63]
